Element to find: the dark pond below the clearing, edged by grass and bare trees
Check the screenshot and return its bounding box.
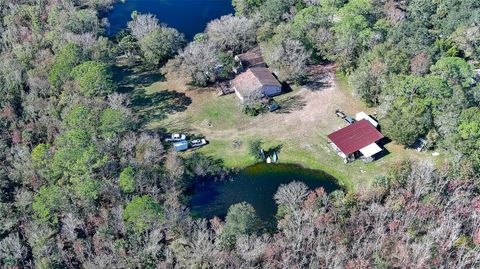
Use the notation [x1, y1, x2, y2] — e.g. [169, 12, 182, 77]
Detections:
[190, 163, 340, 220]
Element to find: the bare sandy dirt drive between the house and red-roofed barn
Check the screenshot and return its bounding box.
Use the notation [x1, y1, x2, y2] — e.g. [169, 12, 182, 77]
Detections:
[187, 63, 365, 138]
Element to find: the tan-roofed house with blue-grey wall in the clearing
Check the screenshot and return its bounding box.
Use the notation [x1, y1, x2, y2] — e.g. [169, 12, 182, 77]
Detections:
[231, 67, 282, 101]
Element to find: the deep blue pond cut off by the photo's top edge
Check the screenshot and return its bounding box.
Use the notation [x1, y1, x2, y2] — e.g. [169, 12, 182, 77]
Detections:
[107, 0, 234, 40]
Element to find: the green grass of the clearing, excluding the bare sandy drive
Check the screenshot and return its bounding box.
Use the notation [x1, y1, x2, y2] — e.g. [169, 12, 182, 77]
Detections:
[118, 64, 441, 190]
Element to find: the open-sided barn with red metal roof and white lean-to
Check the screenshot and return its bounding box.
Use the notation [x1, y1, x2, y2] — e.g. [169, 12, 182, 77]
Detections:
[328, 119, 383, 163]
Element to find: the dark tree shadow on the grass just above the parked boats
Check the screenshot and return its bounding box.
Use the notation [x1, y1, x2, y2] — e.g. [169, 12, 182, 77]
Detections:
[132, 89, 192, 124]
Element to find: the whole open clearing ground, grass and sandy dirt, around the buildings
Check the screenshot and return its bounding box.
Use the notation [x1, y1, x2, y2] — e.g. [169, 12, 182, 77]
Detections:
[117, 63, 443, 191]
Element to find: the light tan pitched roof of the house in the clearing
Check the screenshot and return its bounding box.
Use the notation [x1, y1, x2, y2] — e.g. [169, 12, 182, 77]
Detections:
[232, 67, 282, 96]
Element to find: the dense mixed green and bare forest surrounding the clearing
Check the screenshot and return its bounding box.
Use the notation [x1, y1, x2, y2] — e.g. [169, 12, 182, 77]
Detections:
[0, 0, 480, 268]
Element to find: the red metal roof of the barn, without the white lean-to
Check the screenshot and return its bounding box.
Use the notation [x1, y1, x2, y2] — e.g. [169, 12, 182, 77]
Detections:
[328, 119, 383, 155]
